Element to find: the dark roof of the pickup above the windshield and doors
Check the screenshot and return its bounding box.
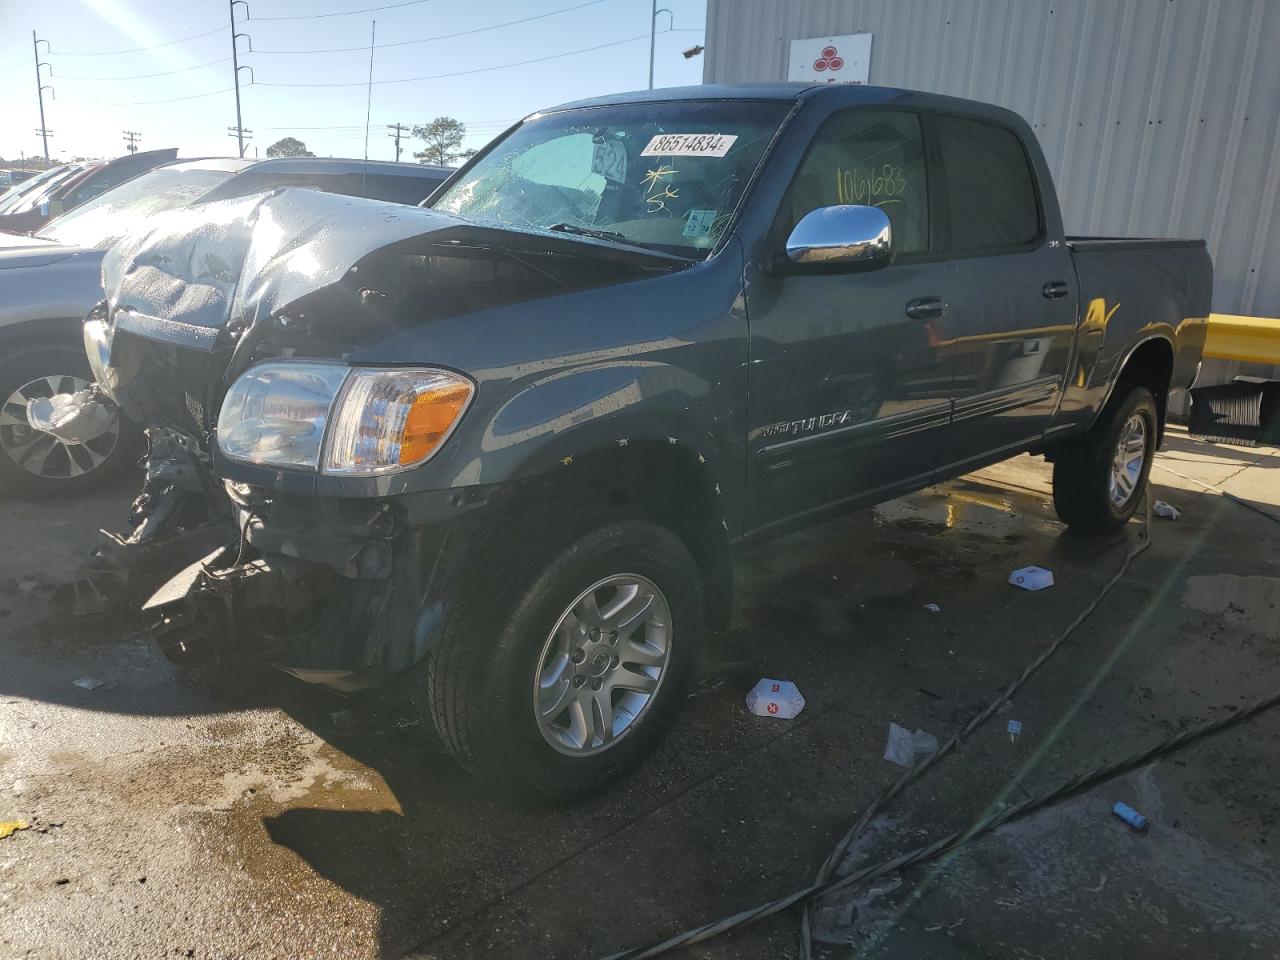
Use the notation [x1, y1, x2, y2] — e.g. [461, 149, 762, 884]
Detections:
[532, 83, 1018, 128]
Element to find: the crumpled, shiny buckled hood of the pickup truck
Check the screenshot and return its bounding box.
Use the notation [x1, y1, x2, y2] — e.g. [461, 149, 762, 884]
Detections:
[102, 189, 471, 349]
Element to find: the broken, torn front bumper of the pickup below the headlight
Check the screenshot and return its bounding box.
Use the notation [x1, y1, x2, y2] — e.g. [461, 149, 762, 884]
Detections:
[143, 484, 506, 689]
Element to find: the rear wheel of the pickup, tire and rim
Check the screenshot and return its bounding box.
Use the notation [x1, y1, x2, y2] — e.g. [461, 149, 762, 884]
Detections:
[1053, 387, 1160, 532]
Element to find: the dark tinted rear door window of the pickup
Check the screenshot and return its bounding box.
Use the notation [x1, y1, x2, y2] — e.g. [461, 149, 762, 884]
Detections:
[934, 116, 1041, 251]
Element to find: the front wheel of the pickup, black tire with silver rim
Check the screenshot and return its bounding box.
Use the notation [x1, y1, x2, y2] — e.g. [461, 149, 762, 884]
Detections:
[435, 522, 703, 800]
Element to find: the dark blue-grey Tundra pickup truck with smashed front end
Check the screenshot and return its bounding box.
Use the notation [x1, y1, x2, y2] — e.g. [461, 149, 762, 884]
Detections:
[77, 84, 1211, 797]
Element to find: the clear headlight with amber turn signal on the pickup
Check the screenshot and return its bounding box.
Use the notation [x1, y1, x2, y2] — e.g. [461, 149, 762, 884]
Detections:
[218, 362, 474, 476]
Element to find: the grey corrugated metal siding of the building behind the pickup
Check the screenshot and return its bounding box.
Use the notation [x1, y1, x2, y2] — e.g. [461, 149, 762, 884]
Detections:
[705, 0, 1280, 316]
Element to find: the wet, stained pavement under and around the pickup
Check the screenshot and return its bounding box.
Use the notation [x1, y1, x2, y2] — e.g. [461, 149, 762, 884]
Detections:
[0, 431, 1280, 959]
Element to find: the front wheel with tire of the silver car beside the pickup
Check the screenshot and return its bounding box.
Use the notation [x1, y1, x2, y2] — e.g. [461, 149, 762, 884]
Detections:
[0, 344, 141, 497]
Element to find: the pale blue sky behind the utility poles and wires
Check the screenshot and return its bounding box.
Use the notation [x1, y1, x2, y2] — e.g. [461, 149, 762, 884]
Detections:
[0, 0, 707, 160]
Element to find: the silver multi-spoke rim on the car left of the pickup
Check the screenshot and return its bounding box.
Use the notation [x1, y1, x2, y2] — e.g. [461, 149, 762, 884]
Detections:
[0, 375, 120, 480]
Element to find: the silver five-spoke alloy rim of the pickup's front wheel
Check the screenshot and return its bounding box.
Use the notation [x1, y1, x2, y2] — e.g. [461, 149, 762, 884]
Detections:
[534, 573, 671, 756]
